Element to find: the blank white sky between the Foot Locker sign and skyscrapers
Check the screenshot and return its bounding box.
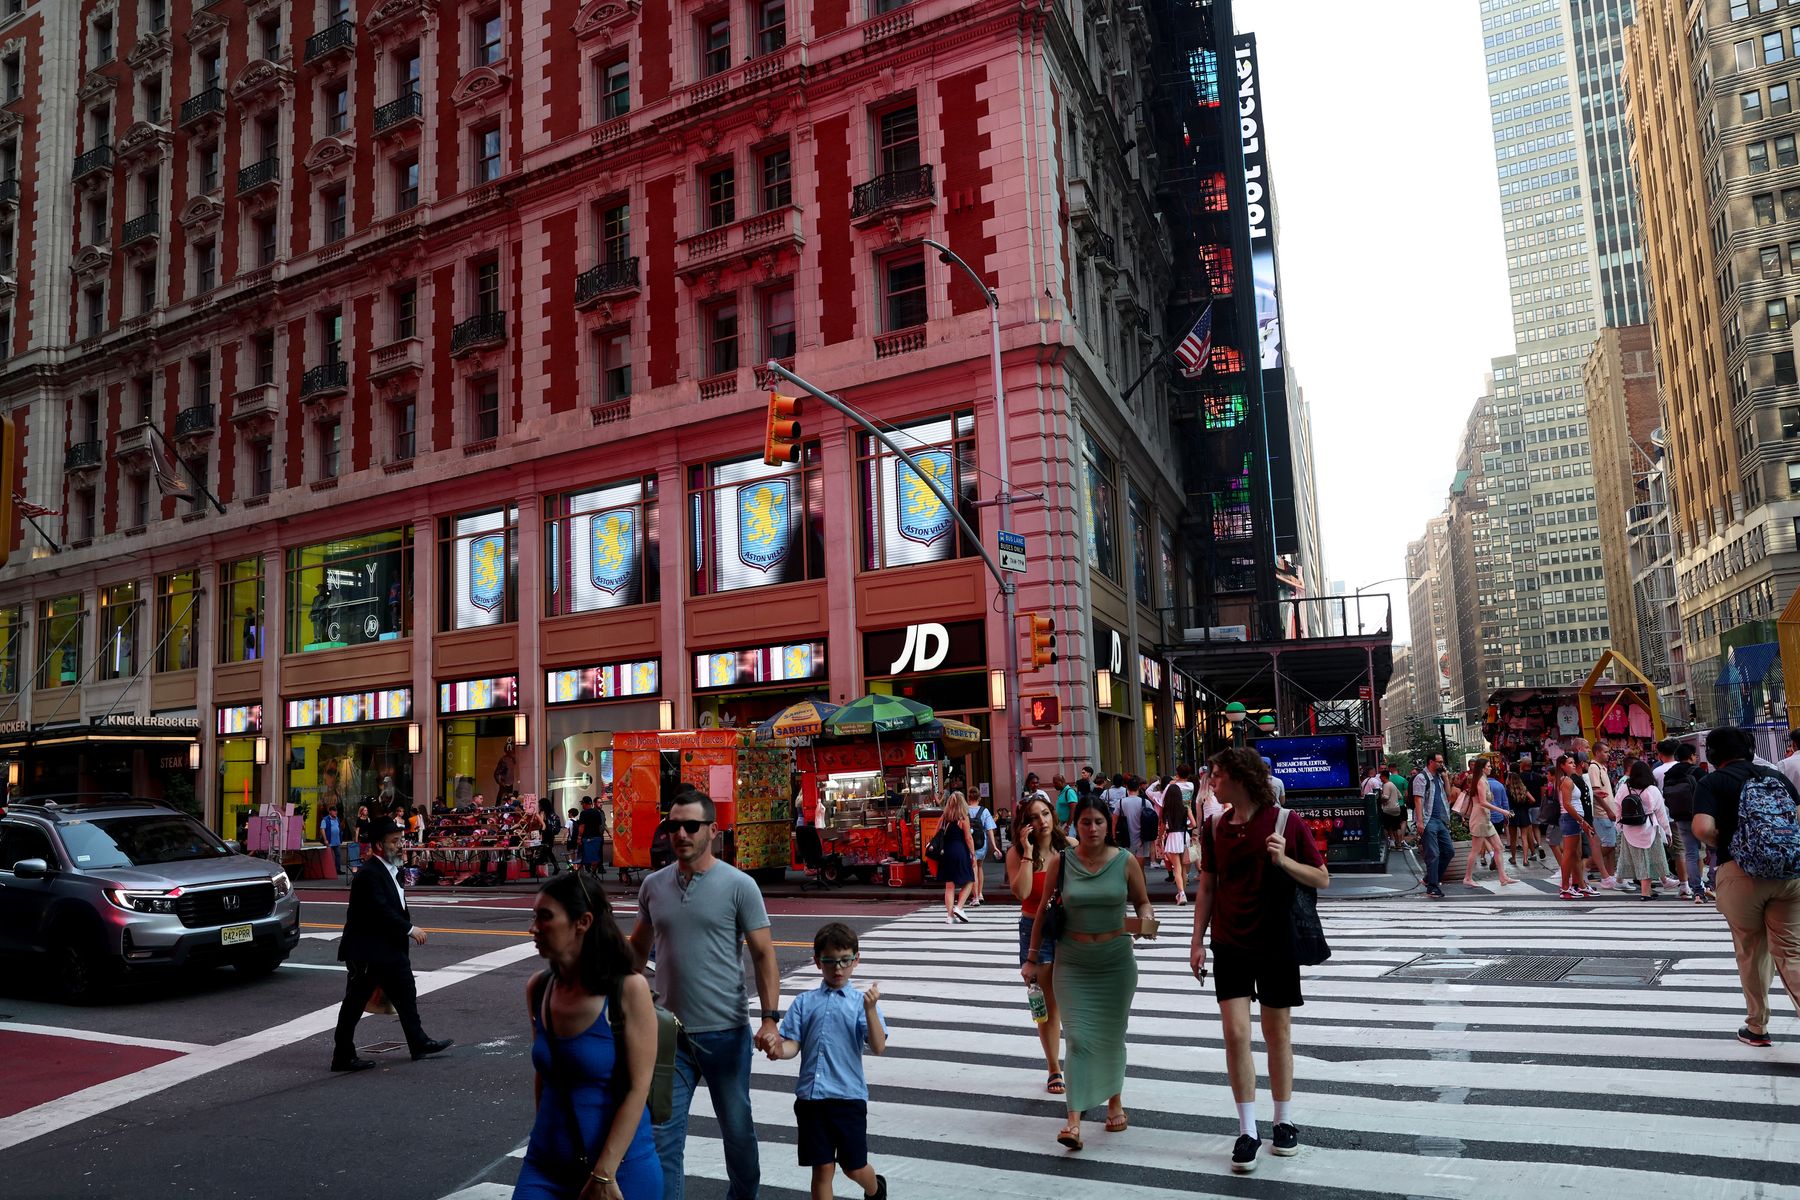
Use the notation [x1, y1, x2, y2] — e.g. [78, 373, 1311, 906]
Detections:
[1235, 0, 1512, 640]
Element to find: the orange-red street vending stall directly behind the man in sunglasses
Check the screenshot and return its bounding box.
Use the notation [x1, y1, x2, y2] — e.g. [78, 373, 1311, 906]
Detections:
[612, 729, 794, 882]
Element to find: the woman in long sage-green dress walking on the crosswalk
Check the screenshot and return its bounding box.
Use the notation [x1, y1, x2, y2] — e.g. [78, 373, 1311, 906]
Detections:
[1024, 793, 1156, 1150]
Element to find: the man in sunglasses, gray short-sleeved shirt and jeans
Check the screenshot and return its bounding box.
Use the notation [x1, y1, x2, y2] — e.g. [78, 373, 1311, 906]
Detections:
[632, 792, 781, 1200]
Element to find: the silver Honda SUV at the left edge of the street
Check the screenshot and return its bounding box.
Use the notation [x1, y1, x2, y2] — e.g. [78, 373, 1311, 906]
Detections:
[0, 795, 301, 1002]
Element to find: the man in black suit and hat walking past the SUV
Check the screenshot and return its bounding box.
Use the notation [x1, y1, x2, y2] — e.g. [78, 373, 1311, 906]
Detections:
[331, 817, 450, 1070]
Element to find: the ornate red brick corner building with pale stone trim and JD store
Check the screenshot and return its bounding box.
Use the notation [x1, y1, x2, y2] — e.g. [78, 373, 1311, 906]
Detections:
[0, 0, 1195, 829]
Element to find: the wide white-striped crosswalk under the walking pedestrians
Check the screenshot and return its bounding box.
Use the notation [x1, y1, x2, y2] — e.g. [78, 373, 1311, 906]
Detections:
[442, 896, 1800, 1200]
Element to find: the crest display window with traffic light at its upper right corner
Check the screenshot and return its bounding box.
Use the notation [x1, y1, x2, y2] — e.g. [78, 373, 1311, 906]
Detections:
[688, 443, 824, 596]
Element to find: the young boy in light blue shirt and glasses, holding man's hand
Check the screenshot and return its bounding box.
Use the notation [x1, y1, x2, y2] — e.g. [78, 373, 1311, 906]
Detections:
[769, 921, 887, 1200]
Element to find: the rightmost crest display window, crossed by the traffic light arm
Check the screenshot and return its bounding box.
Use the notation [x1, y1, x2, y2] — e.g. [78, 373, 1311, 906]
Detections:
[857, 412, 981, 570]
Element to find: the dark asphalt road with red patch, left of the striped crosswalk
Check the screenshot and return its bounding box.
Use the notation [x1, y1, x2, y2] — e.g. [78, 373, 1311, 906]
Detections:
[0, 877, 916, 1200]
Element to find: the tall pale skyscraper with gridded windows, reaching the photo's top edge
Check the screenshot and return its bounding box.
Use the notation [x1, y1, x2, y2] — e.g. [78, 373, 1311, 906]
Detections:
[1480, 0, 1647, 685]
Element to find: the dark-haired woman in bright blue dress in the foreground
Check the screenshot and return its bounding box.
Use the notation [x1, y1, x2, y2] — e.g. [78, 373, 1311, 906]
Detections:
[513, 871, 662, 1200]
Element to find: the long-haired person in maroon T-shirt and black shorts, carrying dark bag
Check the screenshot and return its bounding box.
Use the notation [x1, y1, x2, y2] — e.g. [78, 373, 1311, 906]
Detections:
[1188, 748, 1332, 1173]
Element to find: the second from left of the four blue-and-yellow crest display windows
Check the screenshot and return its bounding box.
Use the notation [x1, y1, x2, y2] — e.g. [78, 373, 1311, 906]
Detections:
[544, 475, 662, 617]
